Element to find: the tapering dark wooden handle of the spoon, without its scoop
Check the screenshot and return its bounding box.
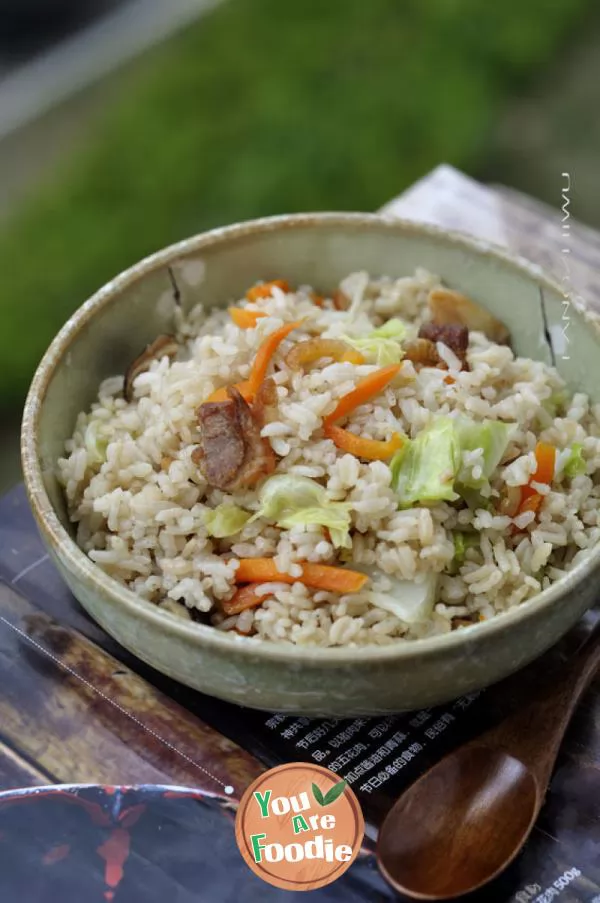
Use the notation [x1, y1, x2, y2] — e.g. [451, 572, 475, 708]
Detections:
[473, 622, 600, 786]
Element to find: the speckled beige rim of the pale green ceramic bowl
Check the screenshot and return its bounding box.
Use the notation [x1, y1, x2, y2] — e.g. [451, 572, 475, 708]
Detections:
[21, 212, 600, 667]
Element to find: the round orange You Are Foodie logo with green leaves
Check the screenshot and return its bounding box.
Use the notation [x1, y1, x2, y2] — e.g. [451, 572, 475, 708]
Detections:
[235, 762, 365, 890]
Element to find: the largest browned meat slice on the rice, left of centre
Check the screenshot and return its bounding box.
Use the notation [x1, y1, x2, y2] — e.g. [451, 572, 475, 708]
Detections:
[192, 386, 276, 491]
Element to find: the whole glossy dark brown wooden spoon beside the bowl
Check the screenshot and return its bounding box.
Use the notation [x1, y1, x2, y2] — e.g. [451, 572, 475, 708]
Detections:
[377, 628, 600, 900]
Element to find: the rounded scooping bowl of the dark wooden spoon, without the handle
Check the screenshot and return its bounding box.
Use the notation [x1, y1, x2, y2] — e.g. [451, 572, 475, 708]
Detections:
[378, 746, 540, 900]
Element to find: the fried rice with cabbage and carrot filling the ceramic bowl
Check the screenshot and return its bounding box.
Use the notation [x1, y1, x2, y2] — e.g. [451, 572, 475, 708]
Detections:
[58, 269, 600, 646]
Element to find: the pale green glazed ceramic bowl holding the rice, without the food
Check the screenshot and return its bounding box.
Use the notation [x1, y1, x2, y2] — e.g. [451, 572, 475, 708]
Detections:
[22, 213, 600, 716]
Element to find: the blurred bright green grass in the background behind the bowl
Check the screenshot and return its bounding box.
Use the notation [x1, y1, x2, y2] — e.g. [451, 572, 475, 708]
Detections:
[0, 0, 592, 409]
